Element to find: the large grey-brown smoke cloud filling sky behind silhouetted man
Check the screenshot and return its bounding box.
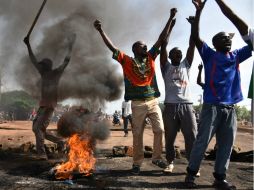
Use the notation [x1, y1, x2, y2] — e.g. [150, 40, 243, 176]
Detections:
[0, 0, 179, 109]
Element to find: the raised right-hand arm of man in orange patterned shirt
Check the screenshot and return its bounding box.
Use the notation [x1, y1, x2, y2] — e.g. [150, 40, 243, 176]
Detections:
[154, 8, 177, 49]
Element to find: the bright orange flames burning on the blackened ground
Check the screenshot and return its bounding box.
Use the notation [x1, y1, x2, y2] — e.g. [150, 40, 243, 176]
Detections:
[55, 134, 96, 179]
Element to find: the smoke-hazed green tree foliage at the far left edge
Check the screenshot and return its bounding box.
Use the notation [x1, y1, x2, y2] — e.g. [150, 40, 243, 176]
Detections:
[0, 91, 37, 120]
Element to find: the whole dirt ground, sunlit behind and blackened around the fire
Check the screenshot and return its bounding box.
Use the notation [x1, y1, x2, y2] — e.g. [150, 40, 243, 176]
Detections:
[0, 121, 253, 190]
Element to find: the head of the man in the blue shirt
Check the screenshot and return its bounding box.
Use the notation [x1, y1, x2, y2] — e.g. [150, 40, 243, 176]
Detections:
[212, 32, 234, 53]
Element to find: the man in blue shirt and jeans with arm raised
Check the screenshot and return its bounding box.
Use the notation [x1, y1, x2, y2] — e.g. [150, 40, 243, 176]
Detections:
[185, 0, 252, 189]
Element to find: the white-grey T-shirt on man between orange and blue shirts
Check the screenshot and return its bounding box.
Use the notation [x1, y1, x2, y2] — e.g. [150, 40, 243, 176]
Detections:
[161, 58, 192, 103]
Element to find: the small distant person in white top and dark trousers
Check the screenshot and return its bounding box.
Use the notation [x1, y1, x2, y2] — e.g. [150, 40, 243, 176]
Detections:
[122, 100, 132, 137]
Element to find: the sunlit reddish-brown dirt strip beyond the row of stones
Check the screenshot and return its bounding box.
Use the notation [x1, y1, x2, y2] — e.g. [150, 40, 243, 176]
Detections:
[0, 121, 253, 152]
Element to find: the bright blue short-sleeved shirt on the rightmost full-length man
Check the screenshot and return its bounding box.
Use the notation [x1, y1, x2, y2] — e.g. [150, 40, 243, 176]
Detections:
[198, 42, 252, 105]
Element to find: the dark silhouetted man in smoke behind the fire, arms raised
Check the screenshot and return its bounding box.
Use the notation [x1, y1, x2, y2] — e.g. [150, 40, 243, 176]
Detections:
[24, 36, 76, 160]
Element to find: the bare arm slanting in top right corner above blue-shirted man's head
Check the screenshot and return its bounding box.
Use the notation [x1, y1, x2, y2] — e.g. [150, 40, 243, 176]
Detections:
[215, 0, 248, 36]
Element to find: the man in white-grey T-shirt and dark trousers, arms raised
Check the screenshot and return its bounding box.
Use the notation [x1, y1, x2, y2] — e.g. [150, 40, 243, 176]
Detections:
[160, 10, 197, 175]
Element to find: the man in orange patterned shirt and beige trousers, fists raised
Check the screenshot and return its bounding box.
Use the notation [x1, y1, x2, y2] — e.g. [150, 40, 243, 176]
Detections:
[94, 7, 177, 175]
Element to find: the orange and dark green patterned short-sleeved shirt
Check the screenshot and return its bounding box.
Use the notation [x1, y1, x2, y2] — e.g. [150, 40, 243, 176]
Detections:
[113, 47, 160, 100]
